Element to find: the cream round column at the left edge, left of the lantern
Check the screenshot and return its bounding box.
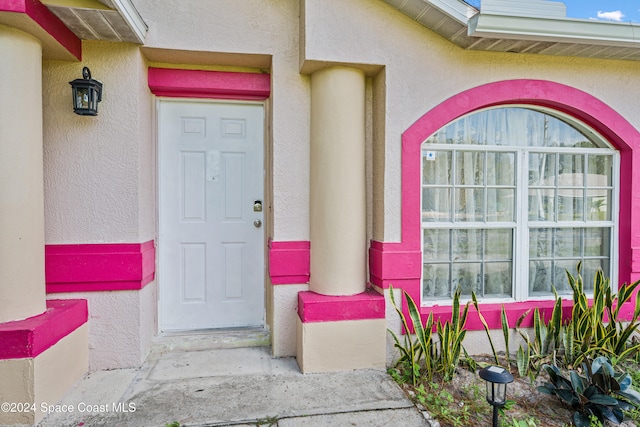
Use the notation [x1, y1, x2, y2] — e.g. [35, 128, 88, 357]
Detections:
[0, 25, 46, 323]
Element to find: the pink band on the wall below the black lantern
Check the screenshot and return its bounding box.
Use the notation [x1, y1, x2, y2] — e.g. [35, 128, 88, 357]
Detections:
[45, 240, 156, 293]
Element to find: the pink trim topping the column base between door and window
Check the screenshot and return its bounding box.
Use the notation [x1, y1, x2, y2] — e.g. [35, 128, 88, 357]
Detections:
[298, 290, 385, 323]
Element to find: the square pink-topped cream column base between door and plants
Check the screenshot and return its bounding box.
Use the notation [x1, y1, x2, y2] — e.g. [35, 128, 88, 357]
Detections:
[296, 291, 387, 373]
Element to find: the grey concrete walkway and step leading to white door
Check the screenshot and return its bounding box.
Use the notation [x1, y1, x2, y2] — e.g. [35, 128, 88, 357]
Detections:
[40, 340, 431, 427]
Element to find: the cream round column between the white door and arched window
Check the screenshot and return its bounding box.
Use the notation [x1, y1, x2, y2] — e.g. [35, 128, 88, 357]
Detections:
[310, 67, 367, 295]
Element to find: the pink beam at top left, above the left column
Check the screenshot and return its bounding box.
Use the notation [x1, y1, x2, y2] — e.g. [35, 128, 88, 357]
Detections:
[0, 0, 82, 60]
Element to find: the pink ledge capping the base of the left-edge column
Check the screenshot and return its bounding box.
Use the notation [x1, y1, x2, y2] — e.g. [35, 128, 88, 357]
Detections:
[0, 299, 88, 360]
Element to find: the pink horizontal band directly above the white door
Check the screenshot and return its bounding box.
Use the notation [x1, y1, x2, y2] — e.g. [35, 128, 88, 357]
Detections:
[149, 68, 271, 100]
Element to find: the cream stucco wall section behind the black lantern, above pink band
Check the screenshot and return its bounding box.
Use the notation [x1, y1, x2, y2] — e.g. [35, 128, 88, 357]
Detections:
[43, 42, 156, 244]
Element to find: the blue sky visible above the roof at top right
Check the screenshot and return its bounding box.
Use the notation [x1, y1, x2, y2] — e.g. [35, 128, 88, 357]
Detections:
[467, 0, 640, 23]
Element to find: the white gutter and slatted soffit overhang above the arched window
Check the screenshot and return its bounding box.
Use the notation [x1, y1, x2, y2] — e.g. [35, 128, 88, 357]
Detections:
[383, 0, 640, 61]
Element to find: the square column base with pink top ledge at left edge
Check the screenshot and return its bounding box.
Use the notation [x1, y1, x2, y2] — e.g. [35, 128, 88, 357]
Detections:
[0, 300, 89, 426]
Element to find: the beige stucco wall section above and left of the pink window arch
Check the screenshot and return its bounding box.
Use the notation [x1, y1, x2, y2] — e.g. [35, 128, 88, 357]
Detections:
[302, 0, 640, 242]
